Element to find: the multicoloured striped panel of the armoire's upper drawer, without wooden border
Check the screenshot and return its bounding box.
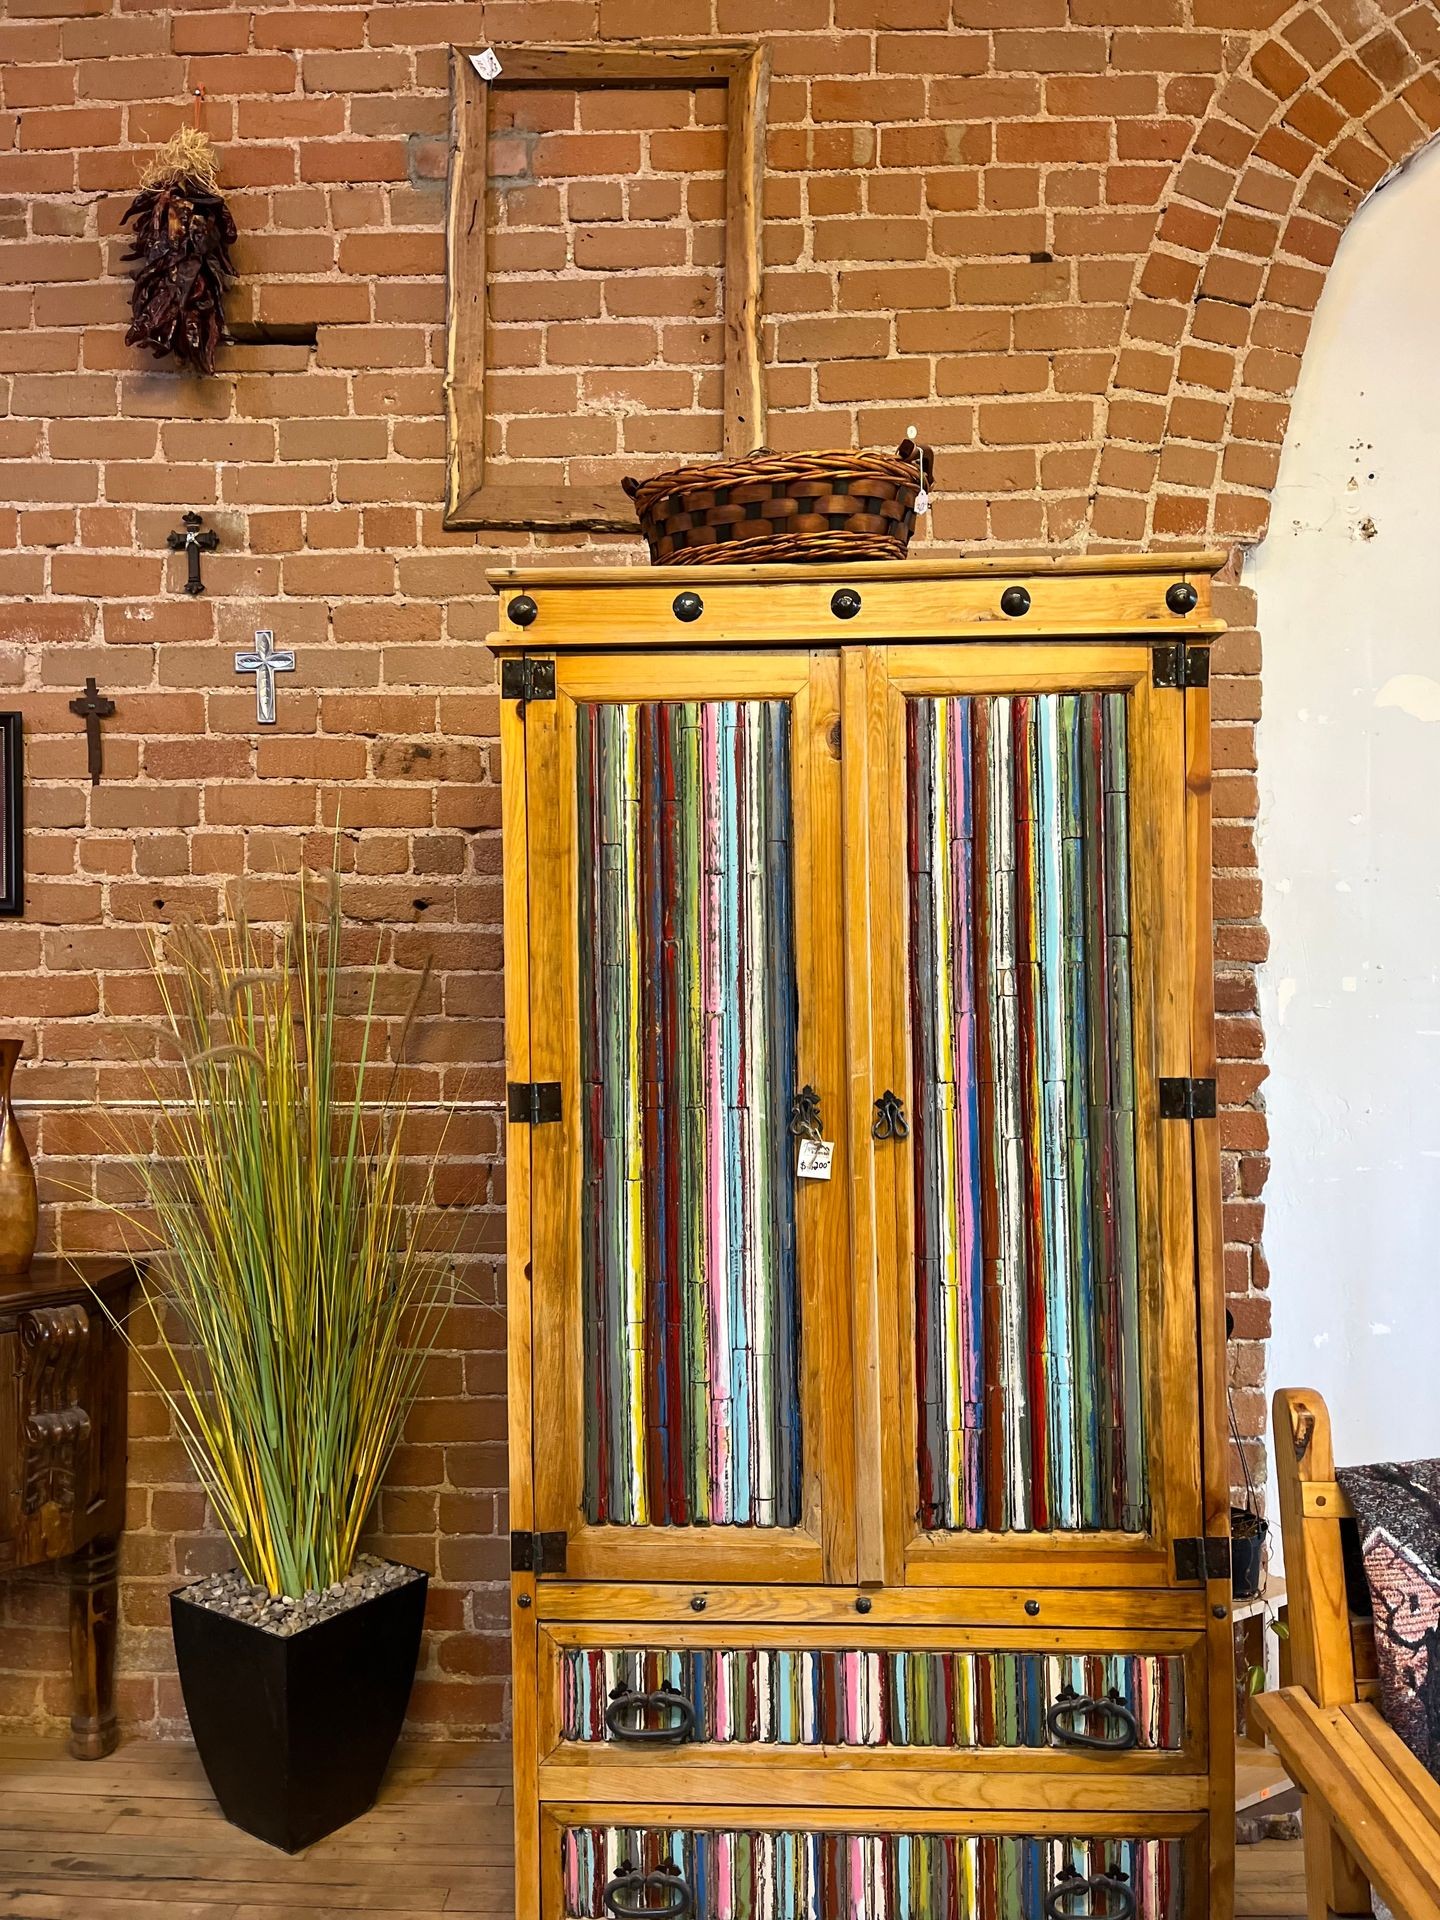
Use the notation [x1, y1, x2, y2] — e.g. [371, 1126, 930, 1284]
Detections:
[561, 1645, 1185, 1751]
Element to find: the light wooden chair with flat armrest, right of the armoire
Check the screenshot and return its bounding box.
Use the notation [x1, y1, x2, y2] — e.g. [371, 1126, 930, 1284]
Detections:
[1250, 1388, 1440, 1920]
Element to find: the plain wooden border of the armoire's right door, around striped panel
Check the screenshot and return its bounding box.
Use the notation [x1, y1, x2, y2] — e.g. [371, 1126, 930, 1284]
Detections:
[864, 641, 1202, 1586]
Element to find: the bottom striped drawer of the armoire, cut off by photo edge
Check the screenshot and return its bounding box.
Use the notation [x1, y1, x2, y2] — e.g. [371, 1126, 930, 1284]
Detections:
[541, 1809, 1208, 1920]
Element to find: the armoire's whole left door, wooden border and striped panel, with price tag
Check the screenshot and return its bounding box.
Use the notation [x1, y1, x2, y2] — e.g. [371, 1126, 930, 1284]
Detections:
[526, 657, 849, 1578]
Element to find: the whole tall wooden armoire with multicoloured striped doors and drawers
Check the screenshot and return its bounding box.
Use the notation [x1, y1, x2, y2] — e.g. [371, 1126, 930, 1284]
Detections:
[493, 553, 1235, 1920]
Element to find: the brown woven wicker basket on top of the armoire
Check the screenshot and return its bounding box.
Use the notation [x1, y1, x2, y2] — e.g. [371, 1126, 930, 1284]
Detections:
[620, 440, 933, 566]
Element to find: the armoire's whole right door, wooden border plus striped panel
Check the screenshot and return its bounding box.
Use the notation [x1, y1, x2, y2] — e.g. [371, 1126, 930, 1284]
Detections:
[867, 647, 1200, 1580]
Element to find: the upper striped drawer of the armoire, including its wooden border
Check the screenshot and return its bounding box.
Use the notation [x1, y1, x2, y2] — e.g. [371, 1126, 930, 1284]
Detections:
[540, 1624, 1206, 1797]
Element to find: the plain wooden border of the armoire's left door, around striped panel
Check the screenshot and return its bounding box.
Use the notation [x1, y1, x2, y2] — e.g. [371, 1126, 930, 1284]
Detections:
[524, 651, 854, 1582]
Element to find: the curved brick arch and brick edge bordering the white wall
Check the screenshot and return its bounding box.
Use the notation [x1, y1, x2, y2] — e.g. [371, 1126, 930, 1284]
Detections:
[1077, 0, 1440, 1482]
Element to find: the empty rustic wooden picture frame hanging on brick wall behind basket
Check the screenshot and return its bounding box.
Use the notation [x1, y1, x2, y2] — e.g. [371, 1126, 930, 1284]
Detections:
[445, 40, 770, 532]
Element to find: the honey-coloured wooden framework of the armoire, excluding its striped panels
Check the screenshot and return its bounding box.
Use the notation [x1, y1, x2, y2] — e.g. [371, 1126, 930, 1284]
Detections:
[493, 555, 1233, 1920]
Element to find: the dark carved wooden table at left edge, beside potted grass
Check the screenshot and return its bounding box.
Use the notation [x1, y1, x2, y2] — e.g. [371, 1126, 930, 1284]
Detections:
[0, 1260, 138, 1761]
